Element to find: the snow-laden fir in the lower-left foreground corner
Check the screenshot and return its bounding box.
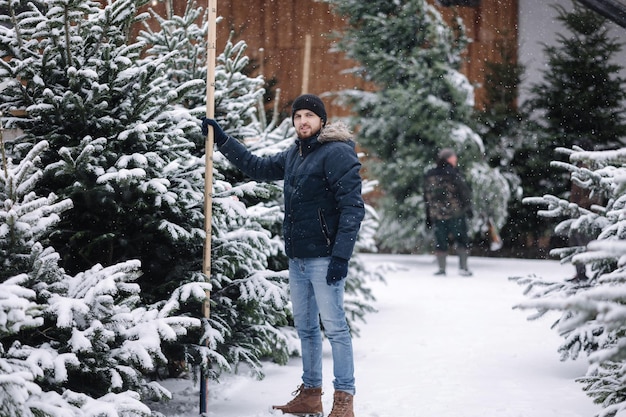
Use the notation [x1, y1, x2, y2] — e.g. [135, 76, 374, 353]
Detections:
[0, 132, 209, 417]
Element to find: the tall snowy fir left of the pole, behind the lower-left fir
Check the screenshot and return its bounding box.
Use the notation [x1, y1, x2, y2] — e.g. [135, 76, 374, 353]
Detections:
[0, 0, 204, 301]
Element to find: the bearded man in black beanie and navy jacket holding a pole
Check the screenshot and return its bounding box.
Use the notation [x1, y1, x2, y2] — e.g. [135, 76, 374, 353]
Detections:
[202, 94, 365, 417]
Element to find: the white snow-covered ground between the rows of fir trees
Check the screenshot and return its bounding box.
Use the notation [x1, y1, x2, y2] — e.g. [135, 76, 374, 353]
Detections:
[146, 255, 600, 417]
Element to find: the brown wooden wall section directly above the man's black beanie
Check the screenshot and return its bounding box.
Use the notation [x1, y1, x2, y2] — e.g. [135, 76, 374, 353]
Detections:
[212, 0, 365, 118]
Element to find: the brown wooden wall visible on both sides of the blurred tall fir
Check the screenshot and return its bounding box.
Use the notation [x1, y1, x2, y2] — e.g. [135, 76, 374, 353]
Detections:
[145, 0, 518, 119]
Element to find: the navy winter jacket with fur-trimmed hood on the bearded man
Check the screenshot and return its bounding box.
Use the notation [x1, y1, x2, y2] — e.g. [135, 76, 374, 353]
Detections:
[219, 123, 365, 259]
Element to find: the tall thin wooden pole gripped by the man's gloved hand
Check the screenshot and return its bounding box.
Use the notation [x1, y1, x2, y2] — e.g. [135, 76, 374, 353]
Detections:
[200, 0, 217, 414]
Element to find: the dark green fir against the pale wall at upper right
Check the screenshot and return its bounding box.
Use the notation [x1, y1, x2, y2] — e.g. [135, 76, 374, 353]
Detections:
[528, 3, 626, 154]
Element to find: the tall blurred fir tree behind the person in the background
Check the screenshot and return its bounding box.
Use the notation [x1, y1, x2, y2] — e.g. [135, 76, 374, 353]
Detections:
[327, 0, 510, 251]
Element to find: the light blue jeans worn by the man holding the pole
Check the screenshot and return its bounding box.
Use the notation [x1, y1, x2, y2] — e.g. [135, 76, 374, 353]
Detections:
[289, 258, 355, 395]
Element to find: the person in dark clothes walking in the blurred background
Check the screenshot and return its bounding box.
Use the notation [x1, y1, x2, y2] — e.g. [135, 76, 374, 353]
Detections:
[424, 148, 472, 276]
